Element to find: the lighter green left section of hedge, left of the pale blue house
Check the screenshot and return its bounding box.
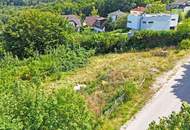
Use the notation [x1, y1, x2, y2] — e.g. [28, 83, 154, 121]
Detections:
[70, 32, 128, 54]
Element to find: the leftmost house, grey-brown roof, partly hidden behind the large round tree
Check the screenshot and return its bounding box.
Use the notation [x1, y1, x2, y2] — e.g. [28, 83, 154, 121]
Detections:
[63, 15, 82, 31]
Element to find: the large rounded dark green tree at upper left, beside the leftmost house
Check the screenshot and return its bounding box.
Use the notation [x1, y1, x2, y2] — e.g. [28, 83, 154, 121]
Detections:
[2, 10, 74, 58]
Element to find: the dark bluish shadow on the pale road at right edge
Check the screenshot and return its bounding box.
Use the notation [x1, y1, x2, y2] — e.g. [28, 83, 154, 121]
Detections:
[172, 64, 190, 103]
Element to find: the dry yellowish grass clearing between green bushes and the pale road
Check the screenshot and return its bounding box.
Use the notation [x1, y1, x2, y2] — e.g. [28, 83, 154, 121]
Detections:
[47, 49, 188, 130]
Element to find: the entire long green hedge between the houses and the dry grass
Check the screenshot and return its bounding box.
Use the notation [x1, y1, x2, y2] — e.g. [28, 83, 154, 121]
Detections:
[72, 31, 190, 54]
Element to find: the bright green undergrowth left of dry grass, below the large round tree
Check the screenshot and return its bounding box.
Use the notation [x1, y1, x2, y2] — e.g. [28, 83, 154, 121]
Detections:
[0, 46, 94, 130]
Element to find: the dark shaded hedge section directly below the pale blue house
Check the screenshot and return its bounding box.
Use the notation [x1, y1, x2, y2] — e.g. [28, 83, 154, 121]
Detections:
[126, 31, 181, 50]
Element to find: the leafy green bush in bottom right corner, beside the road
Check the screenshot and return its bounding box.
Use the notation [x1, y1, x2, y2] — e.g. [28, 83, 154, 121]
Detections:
[149, 103, 190, 130]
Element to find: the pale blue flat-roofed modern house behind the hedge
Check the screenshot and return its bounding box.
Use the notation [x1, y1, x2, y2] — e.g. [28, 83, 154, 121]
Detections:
[127, 14, 179, 31]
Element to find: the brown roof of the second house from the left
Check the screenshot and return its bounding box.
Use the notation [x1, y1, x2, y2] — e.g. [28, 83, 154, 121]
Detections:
[84, 16, 106, 27]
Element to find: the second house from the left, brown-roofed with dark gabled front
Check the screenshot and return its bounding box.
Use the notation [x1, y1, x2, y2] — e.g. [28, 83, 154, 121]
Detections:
[84, 16, 106, 32]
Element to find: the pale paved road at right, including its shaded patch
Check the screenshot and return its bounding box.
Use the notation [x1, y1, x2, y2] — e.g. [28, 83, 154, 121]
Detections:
[121, 60, 190, 130]
